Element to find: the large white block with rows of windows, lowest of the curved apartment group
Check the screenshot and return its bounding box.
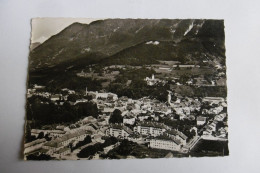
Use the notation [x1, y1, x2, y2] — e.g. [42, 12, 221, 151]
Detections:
[149, 135, 181, 151]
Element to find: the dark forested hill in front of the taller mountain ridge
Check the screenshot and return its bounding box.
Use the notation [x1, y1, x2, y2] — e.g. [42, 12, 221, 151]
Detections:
[98, 39, 223, 66]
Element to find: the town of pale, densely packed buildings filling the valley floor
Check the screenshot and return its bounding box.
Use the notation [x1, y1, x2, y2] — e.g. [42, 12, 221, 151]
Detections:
[24, 72, 228, 160]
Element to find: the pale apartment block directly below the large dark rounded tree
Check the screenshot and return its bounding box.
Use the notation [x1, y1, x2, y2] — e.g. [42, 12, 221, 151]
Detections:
[106, 124, 133, 138]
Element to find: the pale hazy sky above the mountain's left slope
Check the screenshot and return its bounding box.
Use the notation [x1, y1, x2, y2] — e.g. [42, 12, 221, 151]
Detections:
[31, 18, 101, 43]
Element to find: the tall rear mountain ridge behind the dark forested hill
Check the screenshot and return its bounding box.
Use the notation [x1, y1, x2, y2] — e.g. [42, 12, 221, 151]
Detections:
[29, 19, 223, 69]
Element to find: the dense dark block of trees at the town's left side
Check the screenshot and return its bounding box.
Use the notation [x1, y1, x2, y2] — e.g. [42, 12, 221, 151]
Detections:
[27, 96, 98, 128]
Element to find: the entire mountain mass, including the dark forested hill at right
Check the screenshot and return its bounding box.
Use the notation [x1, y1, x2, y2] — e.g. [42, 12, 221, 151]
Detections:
[29, 19, 224, 71]
